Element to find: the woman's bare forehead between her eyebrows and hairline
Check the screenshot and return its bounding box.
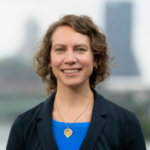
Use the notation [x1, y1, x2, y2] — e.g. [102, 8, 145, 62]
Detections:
[52, 26, 90, 46]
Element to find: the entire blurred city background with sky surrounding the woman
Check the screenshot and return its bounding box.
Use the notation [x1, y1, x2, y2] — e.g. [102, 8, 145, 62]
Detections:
[0, 0, 150, 150]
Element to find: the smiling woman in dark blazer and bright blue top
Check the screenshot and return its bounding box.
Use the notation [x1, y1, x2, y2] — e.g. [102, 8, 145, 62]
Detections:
[6, 15, 146, 150]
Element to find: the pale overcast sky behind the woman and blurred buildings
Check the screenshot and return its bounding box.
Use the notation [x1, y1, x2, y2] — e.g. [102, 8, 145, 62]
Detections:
[0, 0, 150, 86]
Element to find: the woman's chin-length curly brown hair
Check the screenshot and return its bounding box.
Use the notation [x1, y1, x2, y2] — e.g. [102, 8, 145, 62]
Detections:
[30, 15, 113, 96]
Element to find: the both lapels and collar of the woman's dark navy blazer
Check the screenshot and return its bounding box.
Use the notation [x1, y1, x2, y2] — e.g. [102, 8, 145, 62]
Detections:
[37, 89, 107, 150]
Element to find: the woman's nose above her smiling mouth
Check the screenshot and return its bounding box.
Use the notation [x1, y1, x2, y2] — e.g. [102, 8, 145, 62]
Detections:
[64, 50, 77, 64]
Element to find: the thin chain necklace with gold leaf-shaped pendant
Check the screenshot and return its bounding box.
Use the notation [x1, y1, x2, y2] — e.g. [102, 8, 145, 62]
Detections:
[55, 95, 93, 138]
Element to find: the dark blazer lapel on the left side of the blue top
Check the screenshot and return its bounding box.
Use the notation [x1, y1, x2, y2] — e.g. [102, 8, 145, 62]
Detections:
[37, 94, 58, 150]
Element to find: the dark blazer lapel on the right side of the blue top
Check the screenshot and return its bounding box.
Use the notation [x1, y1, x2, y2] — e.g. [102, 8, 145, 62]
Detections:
[80, 89, 107, 150]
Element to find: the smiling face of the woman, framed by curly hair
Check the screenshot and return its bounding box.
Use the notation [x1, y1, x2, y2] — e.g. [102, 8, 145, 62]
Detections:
[49, 26, 95, 88]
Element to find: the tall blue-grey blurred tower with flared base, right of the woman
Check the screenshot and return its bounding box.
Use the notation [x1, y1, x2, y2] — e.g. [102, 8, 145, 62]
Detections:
[105, 2, 139, 76]
